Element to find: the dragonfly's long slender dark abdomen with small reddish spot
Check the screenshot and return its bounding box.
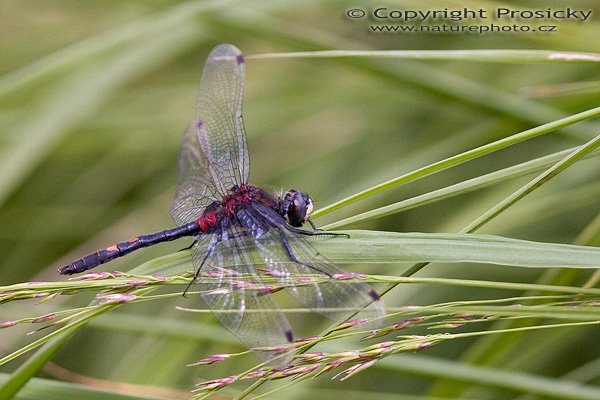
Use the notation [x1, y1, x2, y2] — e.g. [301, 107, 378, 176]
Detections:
[58, 222, 202, 275]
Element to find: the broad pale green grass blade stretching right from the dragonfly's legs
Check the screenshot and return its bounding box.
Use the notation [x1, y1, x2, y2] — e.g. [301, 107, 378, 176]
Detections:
[313, 231, 600, 268]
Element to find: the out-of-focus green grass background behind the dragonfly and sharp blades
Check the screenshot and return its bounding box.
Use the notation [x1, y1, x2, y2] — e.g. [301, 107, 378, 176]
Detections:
[0, 0, 600, 399]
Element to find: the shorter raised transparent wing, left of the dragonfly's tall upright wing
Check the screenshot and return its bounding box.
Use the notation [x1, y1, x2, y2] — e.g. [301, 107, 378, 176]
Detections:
[171, 125, 222, 225]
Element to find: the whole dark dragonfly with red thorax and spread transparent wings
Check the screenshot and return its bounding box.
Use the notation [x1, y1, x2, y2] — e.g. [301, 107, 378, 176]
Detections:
[58, 44, 385, 360]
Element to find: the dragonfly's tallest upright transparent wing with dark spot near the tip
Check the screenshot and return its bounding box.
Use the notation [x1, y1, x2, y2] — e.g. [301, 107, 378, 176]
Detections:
[196, 44, 250, 194]
